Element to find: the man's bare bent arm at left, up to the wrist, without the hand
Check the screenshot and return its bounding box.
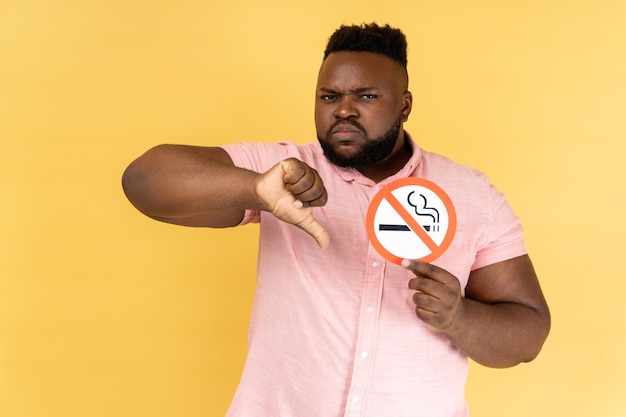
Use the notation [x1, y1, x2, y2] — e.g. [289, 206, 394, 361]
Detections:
[122, 145, 260, 227]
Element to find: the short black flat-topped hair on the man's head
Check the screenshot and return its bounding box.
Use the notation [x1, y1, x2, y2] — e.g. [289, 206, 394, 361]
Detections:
[324, 23, 407, 69]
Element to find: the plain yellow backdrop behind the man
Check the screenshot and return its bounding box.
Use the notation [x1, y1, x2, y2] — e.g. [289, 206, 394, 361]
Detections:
[0, 0, 626, 417]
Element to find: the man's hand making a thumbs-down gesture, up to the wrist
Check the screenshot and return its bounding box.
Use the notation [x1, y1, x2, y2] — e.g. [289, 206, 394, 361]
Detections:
[254, 158, 330, 249]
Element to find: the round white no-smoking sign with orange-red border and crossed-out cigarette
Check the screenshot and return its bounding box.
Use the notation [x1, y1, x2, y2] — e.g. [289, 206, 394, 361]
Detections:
[366, 178, 456, 265]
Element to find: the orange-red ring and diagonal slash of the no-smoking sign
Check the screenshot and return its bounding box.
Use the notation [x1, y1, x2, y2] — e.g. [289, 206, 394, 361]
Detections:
[365, 177, 456, 265]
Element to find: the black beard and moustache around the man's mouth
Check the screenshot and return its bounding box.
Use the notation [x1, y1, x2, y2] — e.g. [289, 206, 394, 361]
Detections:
[317, 115, 402, 169]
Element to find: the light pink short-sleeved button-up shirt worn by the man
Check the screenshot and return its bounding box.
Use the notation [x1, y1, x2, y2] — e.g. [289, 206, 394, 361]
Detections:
[224, 134, 526, 417]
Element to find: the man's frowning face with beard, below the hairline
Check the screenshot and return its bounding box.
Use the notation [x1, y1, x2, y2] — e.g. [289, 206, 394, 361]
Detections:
[315, 52, 411, 168]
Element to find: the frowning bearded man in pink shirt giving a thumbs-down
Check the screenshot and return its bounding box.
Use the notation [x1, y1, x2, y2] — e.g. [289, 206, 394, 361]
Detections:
[123, 24, 550, 417]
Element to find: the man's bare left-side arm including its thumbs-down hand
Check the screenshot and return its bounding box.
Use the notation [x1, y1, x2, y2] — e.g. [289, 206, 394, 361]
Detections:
[122, 145, 329, 249]
